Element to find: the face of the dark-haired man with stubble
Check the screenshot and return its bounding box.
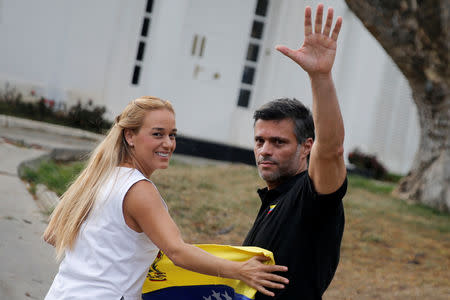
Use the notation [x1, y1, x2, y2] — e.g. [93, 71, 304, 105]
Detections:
[254, 119, 306, 189]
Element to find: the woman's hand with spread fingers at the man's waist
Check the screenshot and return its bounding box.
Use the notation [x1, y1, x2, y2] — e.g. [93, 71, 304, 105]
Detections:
[236, 256, 289, 297]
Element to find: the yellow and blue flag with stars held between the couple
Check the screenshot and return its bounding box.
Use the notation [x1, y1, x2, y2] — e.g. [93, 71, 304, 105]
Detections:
[142, 244, 275, 300]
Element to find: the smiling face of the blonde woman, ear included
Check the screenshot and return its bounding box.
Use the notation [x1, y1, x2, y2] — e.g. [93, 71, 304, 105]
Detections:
[125, 108, 177, 177]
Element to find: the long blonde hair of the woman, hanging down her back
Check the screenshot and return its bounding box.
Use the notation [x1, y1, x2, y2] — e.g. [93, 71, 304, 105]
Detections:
[44, 96, 174, 259]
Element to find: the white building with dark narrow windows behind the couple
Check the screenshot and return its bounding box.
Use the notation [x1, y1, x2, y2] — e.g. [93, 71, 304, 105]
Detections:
[0, 0, 419, 173]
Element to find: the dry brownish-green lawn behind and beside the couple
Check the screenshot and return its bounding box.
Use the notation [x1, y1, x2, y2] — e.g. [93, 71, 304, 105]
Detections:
[22, 161, 450, 300]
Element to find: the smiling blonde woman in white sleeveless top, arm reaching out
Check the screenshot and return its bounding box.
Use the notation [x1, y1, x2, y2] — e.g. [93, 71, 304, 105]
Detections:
[44, 97, 288, 300]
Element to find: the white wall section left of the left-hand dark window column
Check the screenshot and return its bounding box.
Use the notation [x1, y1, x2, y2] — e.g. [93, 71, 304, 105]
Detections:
[0, 0, 135, 104]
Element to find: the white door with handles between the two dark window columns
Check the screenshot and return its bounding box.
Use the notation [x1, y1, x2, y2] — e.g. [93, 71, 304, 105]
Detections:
[173, 0, 255, 144]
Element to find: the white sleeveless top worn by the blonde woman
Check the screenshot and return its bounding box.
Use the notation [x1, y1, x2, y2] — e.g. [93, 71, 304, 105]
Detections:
[45, 167, 167, 300]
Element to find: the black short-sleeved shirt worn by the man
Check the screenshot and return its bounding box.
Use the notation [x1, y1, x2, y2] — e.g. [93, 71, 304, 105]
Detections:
[243, 171, 347, 300]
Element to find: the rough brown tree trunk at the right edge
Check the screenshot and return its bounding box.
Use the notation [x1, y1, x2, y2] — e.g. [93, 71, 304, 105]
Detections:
[345, 0, 450, 211]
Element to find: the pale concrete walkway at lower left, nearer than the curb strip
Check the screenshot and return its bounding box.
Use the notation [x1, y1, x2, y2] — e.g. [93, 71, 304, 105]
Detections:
[0, 139, 57, 300]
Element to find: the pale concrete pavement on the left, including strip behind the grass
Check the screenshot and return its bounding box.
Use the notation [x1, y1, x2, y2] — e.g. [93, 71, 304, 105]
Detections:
[0, 116, 100, 300]
